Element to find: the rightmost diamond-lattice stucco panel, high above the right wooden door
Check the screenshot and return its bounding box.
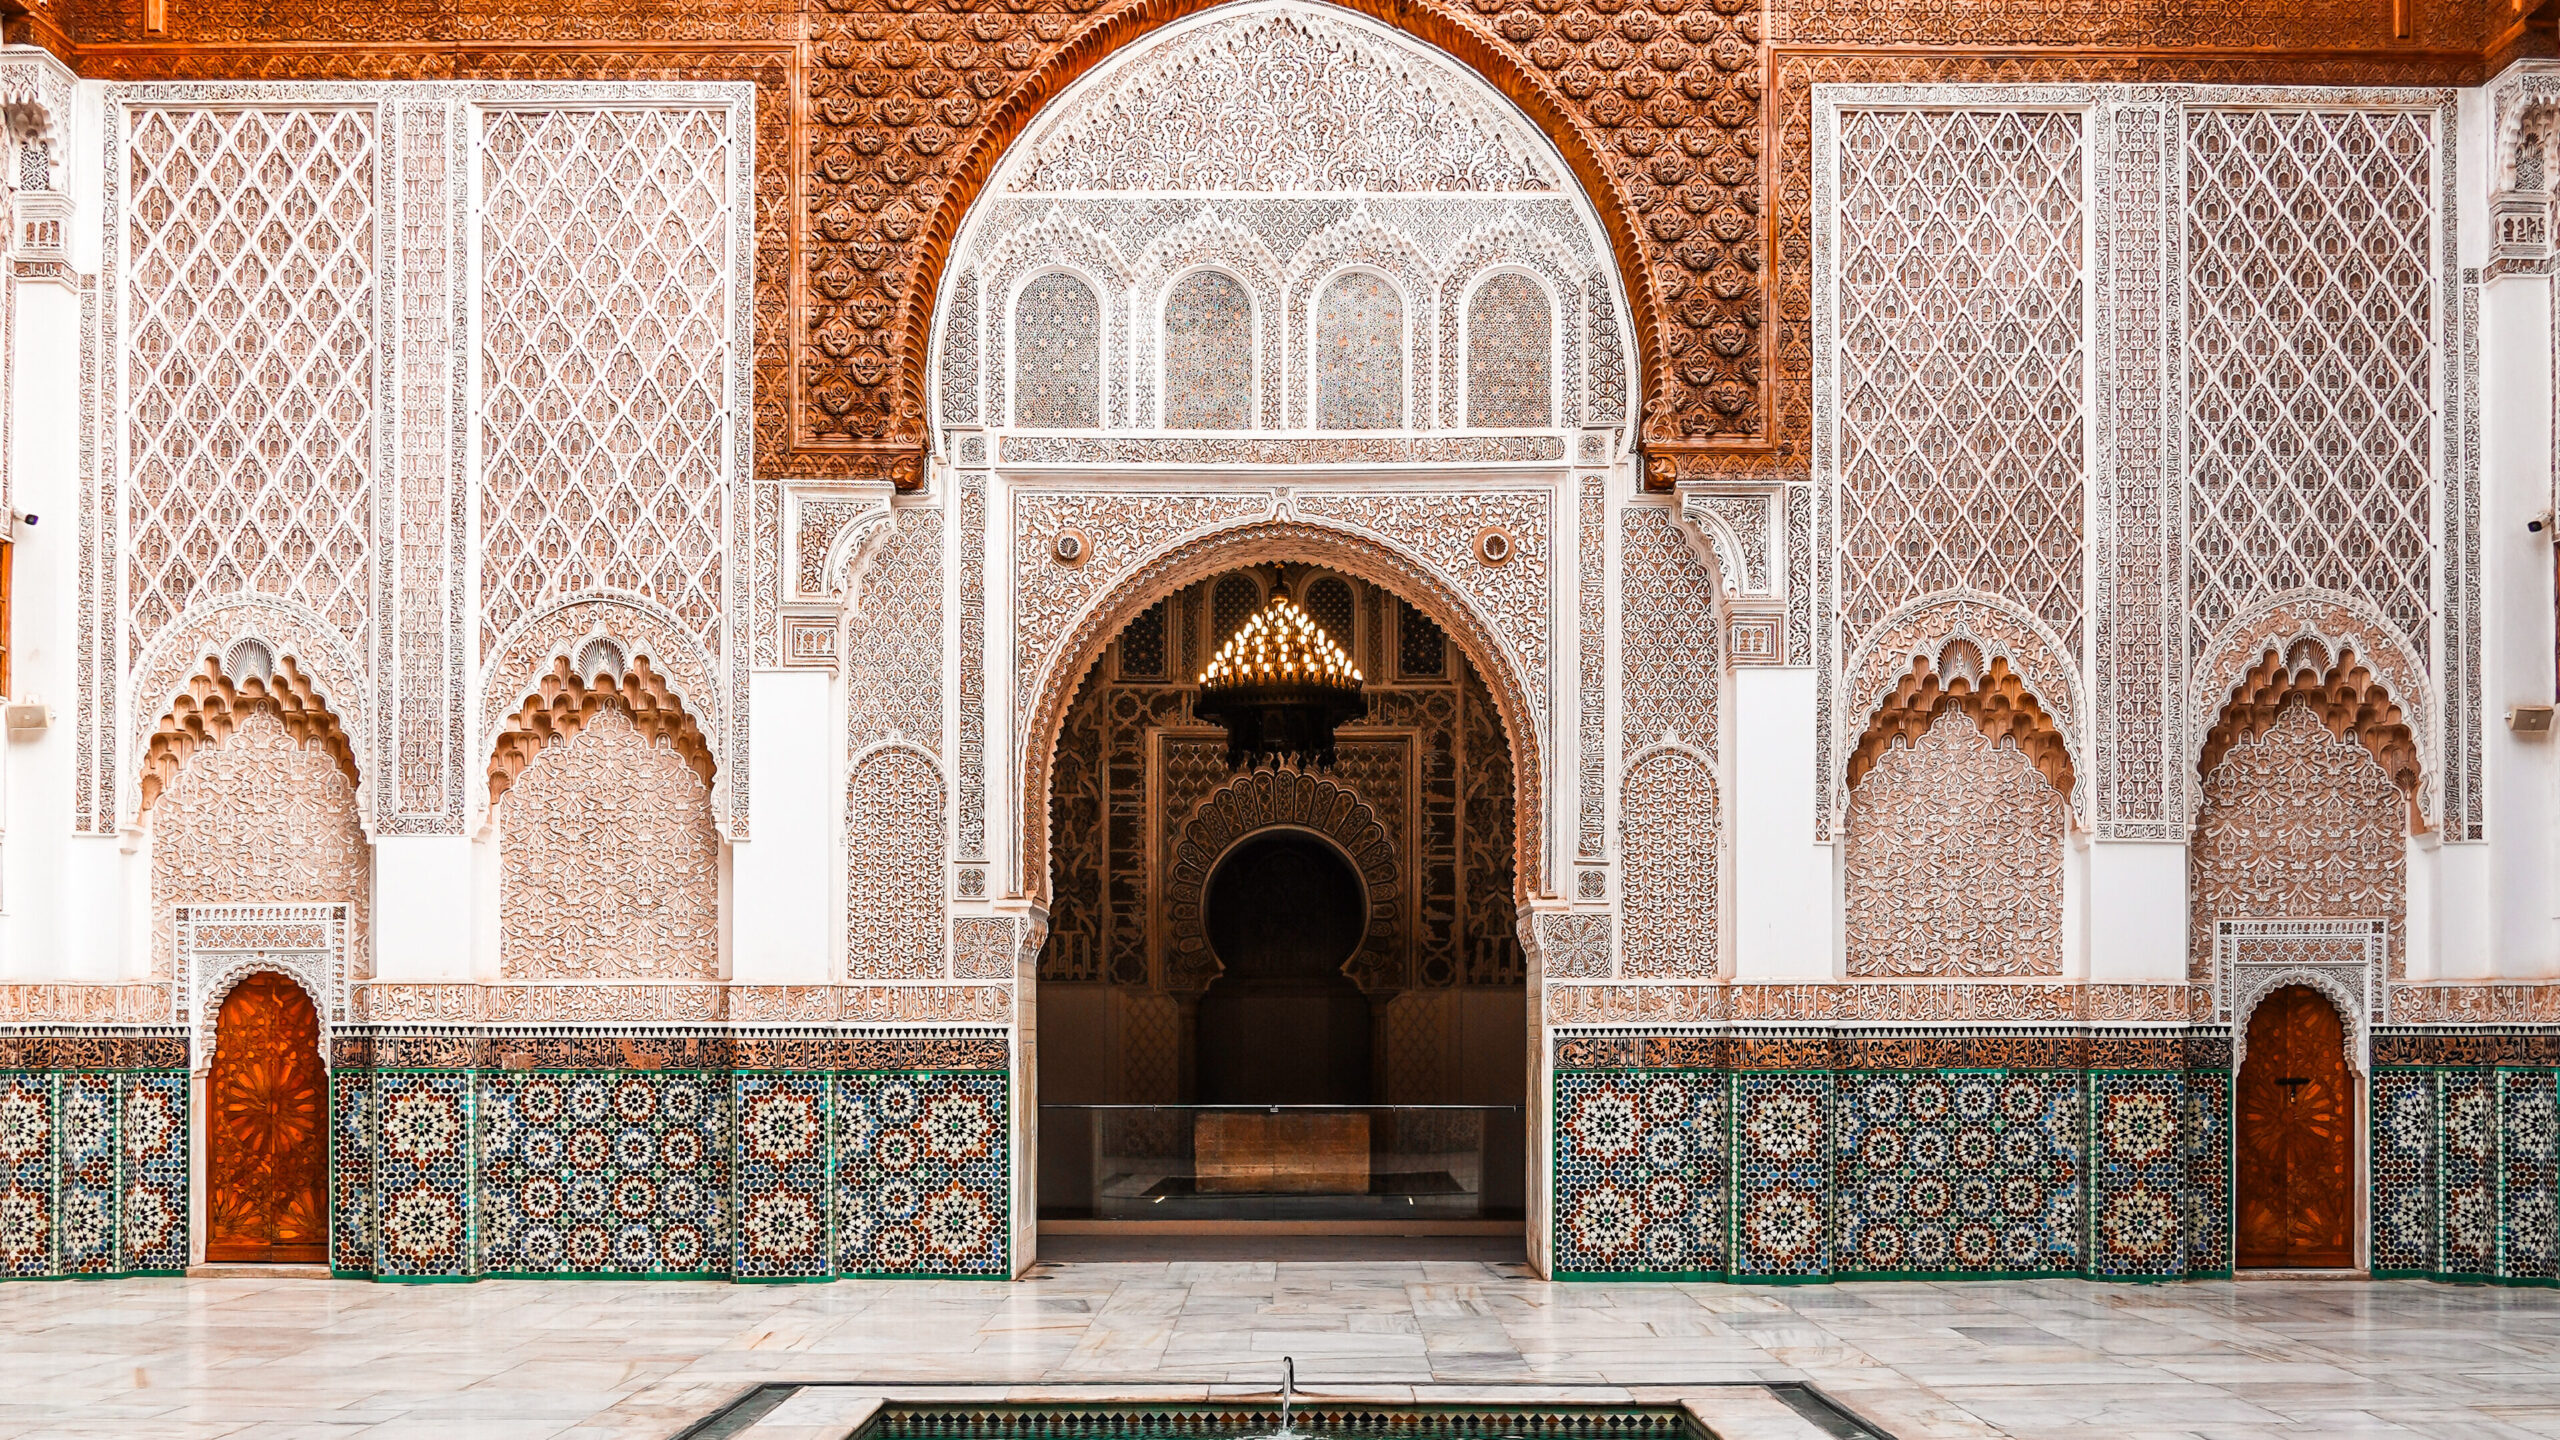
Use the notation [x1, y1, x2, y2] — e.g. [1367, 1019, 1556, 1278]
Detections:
[2186, 110, 2437, 653]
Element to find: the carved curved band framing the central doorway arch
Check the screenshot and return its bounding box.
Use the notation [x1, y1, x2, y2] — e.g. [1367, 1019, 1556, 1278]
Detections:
[1014, 518, 1551, 902]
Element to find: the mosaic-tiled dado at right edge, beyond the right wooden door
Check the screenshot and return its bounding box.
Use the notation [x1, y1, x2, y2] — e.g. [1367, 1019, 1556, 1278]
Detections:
[2368, 1027, 2560, 1284]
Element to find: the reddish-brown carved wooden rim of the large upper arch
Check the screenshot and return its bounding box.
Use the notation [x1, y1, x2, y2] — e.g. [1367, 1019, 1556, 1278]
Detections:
[893, 0, 1679, 450]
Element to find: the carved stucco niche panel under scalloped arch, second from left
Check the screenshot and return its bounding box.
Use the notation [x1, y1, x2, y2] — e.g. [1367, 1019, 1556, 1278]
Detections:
[497, 702, 719, 979]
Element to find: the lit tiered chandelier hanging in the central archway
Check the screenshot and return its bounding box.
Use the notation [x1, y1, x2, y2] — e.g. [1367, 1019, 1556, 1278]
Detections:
[1193, 594, 1370, 769]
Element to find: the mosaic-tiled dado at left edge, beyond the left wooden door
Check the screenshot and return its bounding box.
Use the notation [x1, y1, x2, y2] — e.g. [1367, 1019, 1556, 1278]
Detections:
[0, 1027, 187, 1279]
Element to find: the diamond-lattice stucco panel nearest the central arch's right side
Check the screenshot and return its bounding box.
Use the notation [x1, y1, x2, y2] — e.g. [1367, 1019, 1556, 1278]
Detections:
[1838, 110, 2086, 646]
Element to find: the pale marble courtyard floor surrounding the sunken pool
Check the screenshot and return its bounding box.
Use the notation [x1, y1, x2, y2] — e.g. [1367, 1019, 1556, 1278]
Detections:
[0, 1250, 2560, 1440]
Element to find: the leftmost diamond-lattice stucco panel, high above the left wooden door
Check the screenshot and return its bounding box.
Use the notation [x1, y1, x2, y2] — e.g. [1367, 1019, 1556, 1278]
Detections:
[123, 108, 381, 659]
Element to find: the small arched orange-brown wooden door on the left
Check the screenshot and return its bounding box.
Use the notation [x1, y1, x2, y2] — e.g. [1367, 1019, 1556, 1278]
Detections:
[205, 974, 328, 1263]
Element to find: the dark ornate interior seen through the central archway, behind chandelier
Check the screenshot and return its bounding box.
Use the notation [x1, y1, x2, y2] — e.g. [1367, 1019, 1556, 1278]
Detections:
[1037, 566, 1531, 1229]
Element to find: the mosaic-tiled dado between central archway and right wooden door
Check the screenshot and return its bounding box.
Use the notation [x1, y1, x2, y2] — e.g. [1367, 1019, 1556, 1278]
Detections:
[1554, 1027, 2230, 1281]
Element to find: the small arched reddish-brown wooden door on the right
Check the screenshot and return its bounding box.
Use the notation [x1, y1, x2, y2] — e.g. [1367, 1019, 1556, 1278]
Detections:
[2237, 986, 2355, 1268]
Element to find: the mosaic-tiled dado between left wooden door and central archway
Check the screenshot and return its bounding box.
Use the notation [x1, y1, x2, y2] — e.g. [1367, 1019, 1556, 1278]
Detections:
[330, 1030, 1011, 1281]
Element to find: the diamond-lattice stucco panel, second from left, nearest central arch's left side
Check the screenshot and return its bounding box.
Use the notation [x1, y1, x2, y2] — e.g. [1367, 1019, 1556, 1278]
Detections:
[481, 110, 732, 653]
